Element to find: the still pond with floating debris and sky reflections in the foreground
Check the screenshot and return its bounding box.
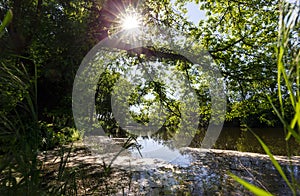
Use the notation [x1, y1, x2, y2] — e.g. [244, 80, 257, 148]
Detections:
[85, 132, 300, 195]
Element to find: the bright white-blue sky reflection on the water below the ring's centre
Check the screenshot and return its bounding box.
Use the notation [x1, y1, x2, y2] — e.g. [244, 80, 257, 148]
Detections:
[130, 137, 192, 166]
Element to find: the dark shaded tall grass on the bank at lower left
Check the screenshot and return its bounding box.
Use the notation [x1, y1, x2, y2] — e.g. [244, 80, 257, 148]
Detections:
[0, 10, 138, 195]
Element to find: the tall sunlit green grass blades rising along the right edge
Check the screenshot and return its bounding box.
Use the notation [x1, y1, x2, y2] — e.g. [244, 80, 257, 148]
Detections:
[274, 3, 300, 144]
